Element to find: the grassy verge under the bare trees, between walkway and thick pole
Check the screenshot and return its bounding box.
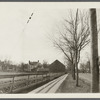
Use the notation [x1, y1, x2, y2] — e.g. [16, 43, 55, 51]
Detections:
[57, 74, 90, 93]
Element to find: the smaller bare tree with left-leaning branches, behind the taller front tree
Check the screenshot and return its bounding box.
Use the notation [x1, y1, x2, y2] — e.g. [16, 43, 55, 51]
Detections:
[53, 40, 75, 80]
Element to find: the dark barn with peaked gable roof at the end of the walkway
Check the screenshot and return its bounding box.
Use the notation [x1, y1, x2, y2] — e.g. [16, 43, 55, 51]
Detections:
[49, 60, 66, 73]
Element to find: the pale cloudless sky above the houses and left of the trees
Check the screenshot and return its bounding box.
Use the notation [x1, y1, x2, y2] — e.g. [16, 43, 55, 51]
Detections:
[0, 2, 100, 63]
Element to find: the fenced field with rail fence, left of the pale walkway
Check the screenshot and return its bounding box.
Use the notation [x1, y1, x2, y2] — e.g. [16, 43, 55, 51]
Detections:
[0, 73, 64, 93]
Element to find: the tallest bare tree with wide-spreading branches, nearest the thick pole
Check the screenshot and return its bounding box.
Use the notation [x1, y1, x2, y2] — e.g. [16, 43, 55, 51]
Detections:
[50, 9, 90, 86]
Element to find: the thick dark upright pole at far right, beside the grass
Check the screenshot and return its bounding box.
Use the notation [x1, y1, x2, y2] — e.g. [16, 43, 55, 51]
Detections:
[90, 9, 99, 93]
